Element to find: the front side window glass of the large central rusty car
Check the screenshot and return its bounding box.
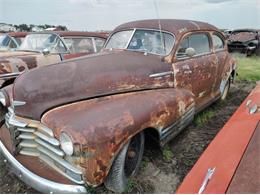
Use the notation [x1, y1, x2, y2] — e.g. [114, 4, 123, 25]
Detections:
[177, 33, 210, 58]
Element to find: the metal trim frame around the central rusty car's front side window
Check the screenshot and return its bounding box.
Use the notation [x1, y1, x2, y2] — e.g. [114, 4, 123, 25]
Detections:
[174, 31, 213, 61]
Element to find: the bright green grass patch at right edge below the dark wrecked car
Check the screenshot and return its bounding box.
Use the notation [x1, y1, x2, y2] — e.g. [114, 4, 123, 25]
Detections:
[235, 56, 260, 82]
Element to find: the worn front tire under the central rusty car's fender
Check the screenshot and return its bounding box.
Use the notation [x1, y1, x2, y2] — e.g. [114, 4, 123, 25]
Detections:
[105, 132, 144, 193]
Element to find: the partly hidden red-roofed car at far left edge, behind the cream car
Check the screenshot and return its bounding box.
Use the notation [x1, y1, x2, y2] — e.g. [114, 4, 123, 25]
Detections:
[0, 32, 27, 52]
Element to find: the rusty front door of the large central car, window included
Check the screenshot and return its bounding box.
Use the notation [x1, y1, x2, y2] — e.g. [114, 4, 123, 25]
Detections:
[173, 32, 217, 109]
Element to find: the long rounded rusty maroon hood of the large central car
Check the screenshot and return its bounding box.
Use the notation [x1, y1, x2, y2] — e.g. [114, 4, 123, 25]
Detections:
[13, 51, 174, 120]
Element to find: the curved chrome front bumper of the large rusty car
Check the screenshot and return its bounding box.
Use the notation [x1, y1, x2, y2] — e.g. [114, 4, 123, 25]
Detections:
[0, 141, 87, 194]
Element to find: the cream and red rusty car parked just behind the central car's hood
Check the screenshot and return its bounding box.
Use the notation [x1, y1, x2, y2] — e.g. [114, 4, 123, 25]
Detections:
[0, 31, 107, 87]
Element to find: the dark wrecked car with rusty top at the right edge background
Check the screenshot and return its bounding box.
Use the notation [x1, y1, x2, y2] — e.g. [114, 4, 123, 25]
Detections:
[228, 29, 260, 56]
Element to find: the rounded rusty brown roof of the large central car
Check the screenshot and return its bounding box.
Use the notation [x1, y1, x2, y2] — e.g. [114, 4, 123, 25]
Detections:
[114, 19, 220, 36]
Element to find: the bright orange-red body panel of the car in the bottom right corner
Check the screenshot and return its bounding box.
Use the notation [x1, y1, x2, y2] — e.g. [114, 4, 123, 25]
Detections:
[176, 84, 260, 194]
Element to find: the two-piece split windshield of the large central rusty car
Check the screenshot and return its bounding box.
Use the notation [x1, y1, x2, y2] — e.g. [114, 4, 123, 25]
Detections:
[106, 29, 174, 55]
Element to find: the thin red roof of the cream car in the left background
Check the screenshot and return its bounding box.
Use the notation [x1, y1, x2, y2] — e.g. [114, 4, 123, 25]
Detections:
[30, 31, 108, 39]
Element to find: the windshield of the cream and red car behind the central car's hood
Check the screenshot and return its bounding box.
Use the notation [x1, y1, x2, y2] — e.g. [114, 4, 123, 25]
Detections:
[19, 33, 67, 53]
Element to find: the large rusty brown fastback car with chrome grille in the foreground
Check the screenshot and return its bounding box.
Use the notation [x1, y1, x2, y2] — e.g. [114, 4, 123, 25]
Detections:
[0, 19, 236, 193]
